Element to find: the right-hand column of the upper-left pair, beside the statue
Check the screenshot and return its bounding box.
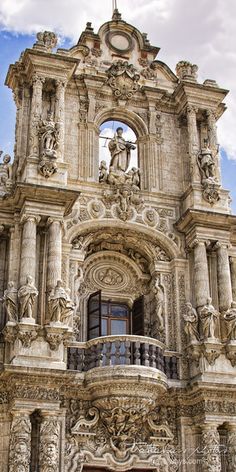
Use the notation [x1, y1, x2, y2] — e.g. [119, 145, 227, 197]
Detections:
[55, 80, 66, 161]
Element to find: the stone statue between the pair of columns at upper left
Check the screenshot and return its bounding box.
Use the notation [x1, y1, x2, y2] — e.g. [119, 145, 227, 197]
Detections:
[39, 111, 59, 159]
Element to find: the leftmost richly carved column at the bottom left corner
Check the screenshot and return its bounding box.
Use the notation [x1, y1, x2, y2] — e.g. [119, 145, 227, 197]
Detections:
[8, 411, 31, 472]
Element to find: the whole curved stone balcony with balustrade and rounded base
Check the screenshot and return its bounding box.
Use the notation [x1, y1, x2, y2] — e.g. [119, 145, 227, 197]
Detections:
[67, 335, 178, 405]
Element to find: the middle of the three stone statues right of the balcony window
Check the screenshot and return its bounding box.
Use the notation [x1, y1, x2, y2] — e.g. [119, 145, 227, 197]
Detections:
[199, 297, 219, 340]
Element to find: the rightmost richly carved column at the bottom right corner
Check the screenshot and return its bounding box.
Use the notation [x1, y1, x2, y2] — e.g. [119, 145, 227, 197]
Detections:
[201, 424, 221, 472]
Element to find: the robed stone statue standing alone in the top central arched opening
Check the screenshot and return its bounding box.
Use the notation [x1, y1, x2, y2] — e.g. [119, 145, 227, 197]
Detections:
[108, 127, 135, 172]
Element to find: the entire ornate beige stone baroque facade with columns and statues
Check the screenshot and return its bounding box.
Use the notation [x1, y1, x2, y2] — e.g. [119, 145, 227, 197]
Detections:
[0, 9, 236, 472]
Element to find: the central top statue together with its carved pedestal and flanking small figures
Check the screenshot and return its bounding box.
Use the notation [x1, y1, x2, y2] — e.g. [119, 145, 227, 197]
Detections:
[99, 120, 142, 221]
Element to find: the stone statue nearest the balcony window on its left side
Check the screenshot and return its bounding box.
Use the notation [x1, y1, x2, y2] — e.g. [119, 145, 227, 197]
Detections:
[48, 280, 75, 326]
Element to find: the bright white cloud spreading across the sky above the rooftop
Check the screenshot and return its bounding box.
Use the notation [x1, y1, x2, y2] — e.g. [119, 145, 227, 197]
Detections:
[0, 0, 236, 159]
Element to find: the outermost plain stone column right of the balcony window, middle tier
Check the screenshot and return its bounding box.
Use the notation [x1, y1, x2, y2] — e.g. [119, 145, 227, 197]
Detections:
[216, 242, 232, 312]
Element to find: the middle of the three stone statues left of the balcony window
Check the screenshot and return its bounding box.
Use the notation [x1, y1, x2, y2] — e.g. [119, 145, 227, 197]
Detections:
[18, 275, 38, 319]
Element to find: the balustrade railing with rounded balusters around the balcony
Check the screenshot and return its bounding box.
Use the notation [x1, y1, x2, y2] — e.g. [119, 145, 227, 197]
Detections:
[67, 335, 178, 379]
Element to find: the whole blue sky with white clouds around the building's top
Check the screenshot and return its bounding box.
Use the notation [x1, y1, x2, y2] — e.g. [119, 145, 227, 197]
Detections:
[0, 0, 236, 213]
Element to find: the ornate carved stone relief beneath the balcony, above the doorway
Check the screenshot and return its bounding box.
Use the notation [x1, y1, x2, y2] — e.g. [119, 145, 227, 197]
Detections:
[66, 398, 174, 471]
